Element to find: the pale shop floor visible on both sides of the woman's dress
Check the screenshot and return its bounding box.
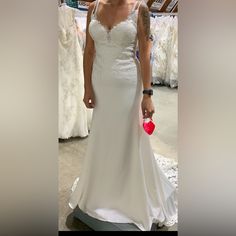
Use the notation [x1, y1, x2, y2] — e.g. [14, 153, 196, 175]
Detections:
[58, 86, 178, 231]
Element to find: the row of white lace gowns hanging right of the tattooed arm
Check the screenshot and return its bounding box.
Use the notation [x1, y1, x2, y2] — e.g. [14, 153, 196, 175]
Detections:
[151, 16, 178, 88]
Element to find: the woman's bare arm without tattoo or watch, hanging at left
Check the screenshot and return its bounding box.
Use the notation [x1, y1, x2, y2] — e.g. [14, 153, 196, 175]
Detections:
[83, 3, 95, 108]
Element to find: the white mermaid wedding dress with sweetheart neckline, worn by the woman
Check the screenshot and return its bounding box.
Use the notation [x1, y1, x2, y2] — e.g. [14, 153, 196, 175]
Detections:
[69, 1, 177, 230]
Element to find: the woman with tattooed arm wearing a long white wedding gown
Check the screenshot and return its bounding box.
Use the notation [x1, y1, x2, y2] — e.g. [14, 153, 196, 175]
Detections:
[70, 0, 177, 230]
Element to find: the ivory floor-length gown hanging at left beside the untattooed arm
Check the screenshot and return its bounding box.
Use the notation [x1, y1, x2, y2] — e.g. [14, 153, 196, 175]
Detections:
[58, 4, 89, 139]
